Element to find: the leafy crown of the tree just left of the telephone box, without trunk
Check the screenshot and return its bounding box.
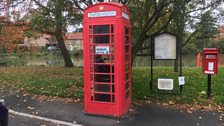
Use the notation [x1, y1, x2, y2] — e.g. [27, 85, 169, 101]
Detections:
[27, 0, 82, 33]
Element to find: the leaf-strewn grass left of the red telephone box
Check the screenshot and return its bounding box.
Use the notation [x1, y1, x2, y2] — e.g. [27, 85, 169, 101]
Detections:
[0, 66, 83, 99]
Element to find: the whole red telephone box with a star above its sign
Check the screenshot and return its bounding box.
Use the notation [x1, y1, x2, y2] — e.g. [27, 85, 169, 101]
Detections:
[83, 2, 132, 117]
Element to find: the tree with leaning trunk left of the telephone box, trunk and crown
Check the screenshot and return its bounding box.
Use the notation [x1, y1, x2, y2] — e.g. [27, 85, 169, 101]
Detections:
[0, 0, 85, 67]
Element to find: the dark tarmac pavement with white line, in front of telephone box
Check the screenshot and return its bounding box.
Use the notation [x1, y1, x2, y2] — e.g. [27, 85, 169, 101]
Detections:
[0, 91, 224, 126]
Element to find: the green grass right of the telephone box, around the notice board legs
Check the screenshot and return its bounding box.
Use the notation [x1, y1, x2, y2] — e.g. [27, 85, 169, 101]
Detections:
[133, 68, 224, 104]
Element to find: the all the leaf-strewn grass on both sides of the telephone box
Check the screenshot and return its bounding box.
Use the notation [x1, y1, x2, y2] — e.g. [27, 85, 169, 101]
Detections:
[0, 66, 224, 104]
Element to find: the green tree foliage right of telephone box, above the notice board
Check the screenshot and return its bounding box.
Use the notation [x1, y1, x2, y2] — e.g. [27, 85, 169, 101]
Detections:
[128, 0, 221, 56]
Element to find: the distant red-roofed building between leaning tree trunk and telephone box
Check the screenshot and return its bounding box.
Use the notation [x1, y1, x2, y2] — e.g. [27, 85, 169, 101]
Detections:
[64, 32, 83, 51]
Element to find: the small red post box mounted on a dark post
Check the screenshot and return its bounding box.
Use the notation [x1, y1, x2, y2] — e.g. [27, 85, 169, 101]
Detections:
[203, 48, 218, 74]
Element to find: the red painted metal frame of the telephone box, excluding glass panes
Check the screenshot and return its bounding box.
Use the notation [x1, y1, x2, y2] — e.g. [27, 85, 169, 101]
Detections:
[83, 2, 132, 117]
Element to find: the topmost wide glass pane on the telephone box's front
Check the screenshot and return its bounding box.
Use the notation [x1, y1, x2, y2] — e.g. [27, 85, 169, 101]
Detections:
[93, 25, 110, 34]
